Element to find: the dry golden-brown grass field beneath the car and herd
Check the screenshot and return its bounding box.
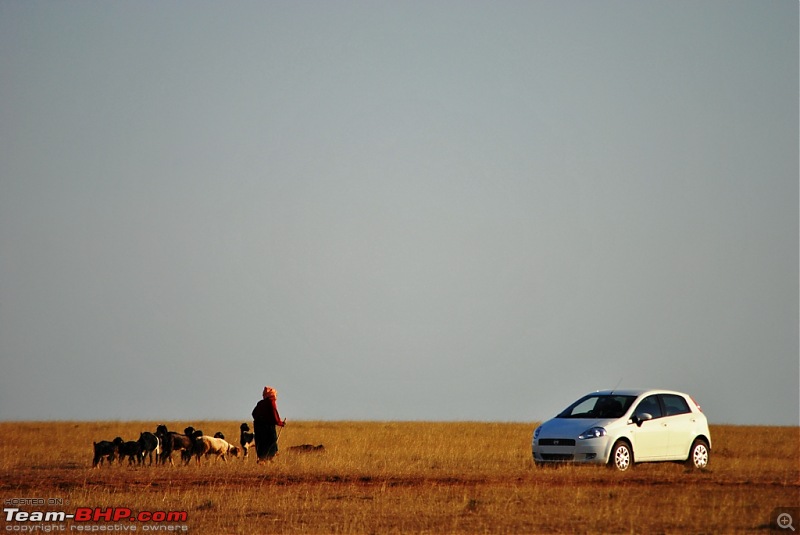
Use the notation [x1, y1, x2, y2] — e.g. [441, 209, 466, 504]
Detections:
[0, 422, 800, 534]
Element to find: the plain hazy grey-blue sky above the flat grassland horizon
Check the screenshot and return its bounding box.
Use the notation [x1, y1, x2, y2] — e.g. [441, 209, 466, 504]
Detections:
[0, 0, 800, 425]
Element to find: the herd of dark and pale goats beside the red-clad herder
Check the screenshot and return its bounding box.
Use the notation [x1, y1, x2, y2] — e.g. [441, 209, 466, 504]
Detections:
[92, 423, 255, 468]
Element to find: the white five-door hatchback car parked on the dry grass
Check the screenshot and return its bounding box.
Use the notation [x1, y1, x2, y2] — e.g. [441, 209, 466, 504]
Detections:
[531, 390, 711, 471]
